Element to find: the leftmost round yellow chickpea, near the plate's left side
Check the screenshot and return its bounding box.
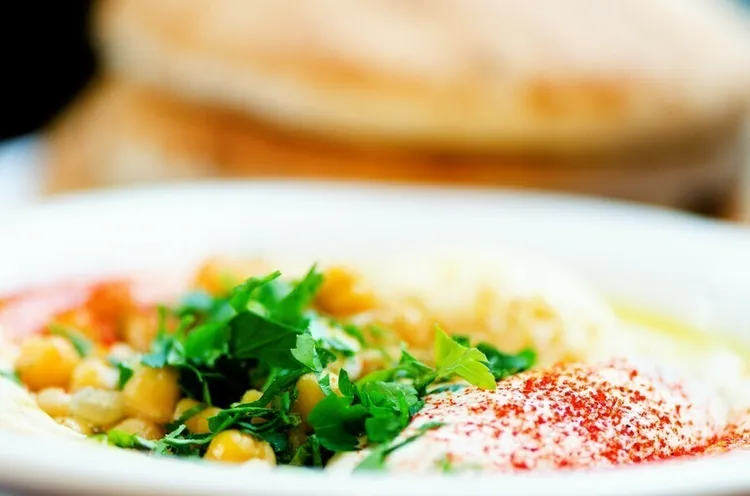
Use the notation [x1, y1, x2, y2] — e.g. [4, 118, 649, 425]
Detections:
[15, 336, 81, 391]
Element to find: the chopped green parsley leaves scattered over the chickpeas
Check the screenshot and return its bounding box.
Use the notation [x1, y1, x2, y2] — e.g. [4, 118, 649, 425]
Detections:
[50, 266, 535, 470]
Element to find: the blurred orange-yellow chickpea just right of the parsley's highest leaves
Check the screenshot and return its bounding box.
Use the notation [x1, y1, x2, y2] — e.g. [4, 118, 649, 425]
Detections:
[316, 267, 377, 316]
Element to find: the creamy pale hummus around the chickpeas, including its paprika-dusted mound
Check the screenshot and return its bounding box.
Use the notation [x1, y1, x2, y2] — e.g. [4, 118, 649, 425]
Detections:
[0, 254, 750, 471]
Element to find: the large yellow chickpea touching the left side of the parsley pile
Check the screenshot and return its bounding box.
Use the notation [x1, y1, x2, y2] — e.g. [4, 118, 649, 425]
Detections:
[123, 366, 180, 424]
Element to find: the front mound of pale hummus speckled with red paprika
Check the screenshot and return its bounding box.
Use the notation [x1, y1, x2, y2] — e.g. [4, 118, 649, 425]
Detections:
[389, 361, 721, 472]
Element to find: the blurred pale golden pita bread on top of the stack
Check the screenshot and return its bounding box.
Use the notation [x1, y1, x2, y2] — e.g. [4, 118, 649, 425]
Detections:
[94, 0, 750, 153]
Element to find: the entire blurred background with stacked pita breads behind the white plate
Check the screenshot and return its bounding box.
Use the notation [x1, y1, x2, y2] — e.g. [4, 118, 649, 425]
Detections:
[0, 0, 750, 219]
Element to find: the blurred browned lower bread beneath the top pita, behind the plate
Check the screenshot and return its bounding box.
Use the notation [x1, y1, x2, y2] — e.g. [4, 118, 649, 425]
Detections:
[47, 80, 744, 214]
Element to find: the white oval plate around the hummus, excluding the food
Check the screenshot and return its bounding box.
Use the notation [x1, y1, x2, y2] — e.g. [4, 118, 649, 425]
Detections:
[0, 182, 750, 496]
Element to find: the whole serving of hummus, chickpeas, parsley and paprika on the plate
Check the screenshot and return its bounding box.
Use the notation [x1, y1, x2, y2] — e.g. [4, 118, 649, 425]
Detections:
[0, 254, 750, 472]
